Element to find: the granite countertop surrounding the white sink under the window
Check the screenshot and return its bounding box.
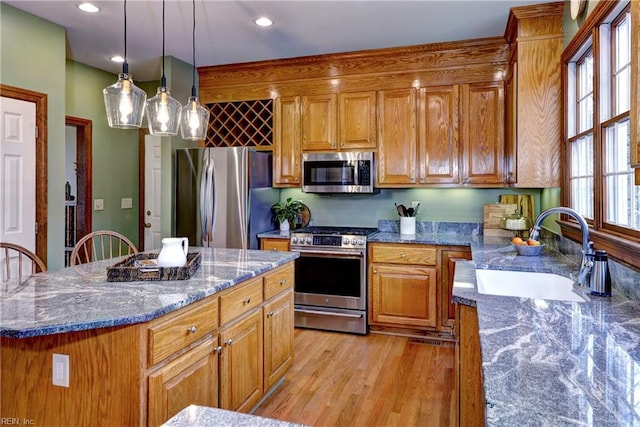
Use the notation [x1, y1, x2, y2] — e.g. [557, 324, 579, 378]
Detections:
[453, 251, 640, 427]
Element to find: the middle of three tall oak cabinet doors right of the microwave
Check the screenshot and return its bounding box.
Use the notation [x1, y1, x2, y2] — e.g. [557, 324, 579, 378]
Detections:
[418, 85, 460, 184]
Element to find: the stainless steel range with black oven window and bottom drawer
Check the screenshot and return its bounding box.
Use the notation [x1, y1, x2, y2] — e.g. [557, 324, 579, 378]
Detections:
[291, 227, 377, 334]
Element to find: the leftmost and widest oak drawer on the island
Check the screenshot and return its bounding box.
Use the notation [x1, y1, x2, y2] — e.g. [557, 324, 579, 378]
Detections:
[147, 298, 218, 365]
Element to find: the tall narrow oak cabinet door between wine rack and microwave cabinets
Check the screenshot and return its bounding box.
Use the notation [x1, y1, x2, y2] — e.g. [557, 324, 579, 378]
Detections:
[273, 96, 302, 187]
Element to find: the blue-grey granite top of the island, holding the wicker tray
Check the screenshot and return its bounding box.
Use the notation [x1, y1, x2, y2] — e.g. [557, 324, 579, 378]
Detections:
[0, 247, 299, 338]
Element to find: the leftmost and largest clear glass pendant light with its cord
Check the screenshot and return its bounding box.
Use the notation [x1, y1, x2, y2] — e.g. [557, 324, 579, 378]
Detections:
[102, 0, 147, 129]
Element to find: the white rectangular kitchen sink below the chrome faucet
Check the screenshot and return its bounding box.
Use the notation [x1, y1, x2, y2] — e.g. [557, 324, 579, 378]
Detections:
[476, 269, 585, 302]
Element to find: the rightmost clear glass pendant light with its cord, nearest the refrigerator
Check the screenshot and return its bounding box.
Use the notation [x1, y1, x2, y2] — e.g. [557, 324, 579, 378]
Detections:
[180, 0, 209, 141]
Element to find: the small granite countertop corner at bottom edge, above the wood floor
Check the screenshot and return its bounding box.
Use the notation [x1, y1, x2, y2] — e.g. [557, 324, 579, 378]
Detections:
[163, 405, 304, 427]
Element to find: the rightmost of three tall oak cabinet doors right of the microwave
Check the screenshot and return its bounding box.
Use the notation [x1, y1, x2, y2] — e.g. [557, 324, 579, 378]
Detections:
[460, 82, 505, 185]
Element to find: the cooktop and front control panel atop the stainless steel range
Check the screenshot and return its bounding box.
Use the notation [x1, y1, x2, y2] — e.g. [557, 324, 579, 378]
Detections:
[291, 226, 378, 249]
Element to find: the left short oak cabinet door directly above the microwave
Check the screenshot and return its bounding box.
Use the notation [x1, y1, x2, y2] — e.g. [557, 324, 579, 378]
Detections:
[302, 93, 338, 151]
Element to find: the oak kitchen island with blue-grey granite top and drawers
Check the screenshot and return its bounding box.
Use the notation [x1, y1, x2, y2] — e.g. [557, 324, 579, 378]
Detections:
[0, 248, 298, 426]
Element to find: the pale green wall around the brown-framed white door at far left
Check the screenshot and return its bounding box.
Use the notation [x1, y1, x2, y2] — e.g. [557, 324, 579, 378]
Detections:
[0, 3, 66, 269]
